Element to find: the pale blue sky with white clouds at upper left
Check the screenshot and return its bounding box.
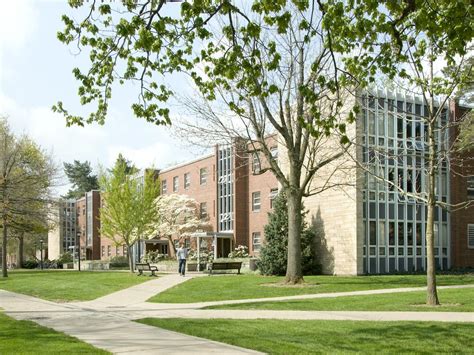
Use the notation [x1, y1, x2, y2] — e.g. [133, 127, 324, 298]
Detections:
[0, 0, 195, 195]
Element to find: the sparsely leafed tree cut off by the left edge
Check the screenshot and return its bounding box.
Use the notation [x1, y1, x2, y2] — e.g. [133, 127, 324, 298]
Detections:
[0, 118, 57, 277]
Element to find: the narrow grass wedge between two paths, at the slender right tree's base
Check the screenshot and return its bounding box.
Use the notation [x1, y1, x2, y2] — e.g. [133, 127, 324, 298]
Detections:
[207, 288, 474, 312]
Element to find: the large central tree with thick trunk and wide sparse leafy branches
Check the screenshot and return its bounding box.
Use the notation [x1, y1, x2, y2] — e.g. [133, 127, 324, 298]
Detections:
[54, 0, 348, 283]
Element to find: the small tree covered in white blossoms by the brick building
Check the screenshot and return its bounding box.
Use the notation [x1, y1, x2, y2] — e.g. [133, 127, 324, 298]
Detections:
[153, 194, 210, 254]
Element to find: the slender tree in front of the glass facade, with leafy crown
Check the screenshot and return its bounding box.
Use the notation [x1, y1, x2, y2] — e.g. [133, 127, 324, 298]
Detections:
[321, 0, 474, 305]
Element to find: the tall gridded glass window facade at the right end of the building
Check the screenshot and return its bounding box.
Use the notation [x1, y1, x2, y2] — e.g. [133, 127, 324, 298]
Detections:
[361, 92, 451, 274]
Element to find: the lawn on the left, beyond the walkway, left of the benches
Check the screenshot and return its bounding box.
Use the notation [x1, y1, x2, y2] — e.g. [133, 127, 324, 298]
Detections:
[0, 270, 151, 302]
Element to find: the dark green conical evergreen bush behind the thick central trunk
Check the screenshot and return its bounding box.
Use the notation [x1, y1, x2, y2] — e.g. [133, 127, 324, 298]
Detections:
[257, 192, 320, 275]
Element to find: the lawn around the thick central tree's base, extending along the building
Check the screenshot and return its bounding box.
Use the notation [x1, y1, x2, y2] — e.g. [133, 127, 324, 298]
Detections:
[148, 274, 474, 303]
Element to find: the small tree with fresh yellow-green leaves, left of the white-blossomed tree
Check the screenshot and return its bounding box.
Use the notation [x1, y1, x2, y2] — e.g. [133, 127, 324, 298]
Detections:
[99, 159, 160, 272]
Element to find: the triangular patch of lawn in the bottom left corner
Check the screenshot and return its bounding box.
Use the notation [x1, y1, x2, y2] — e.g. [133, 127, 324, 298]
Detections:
[0, 312, 109, 354]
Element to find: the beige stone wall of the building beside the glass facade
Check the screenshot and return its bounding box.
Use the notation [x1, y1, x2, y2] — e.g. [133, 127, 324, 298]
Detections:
[279, 94, 363, 275]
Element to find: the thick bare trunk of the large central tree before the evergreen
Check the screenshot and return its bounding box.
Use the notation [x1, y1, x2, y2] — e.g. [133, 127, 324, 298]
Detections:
[285, 188, 304, 284]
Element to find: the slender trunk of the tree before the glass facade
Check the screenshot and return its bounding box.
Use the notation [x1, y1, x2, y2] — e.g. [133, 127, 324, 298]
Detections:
[426, 113, 439, 306]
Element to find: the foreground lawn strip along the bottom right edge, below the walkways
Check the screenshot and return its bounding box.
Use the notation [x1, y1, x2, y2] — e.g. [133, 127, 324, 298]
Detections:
[140, 318, 474, 354]
